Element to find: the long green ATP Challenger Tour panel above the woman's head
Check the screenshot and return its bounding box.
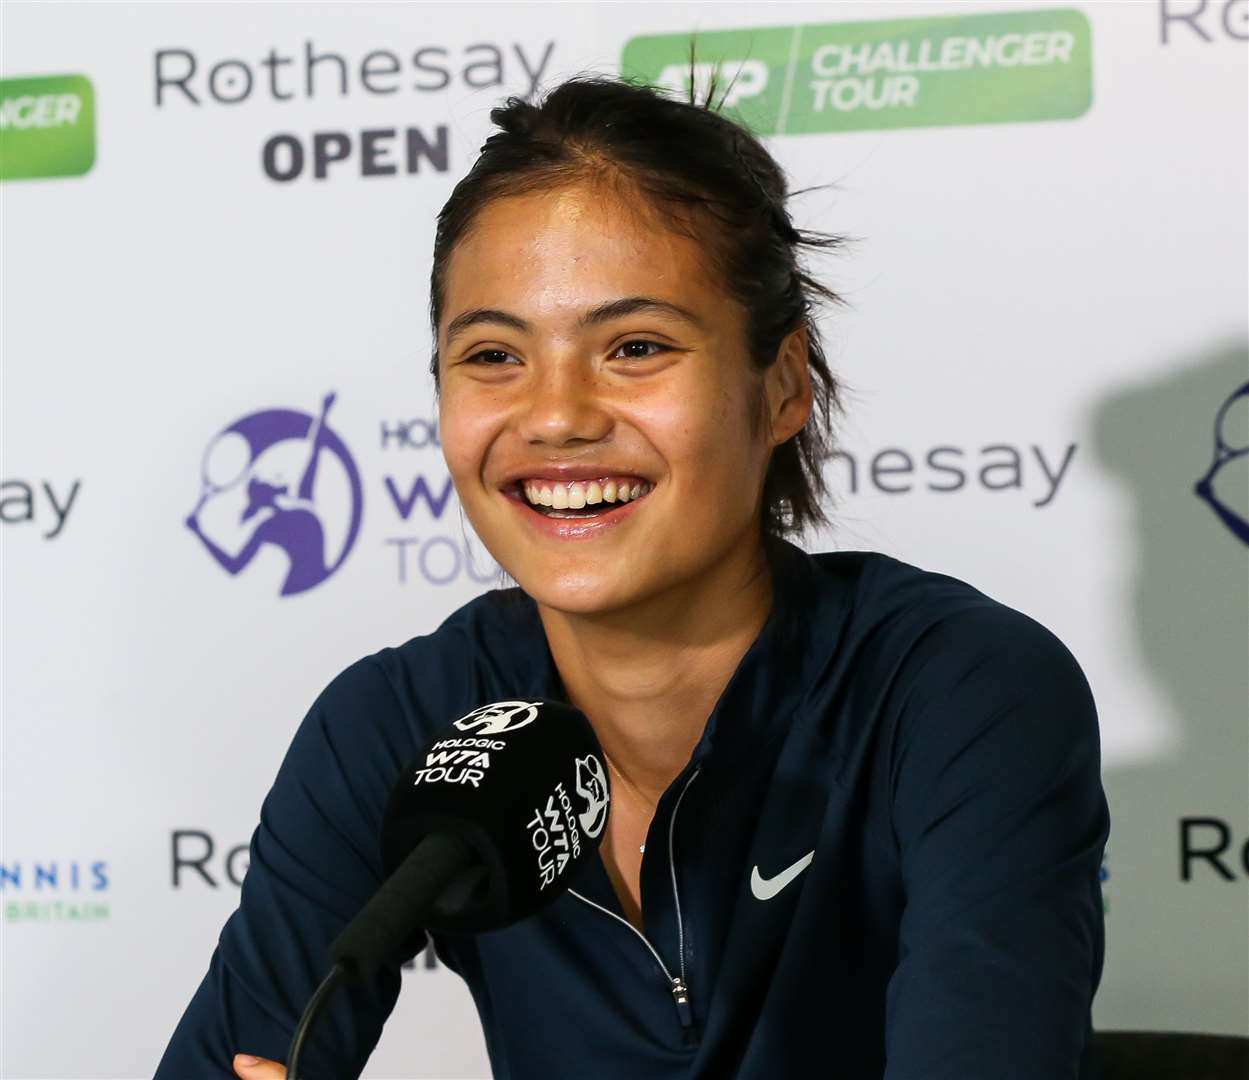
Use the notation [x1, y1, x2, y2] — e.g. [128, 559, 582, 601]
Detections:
[621, 9, 1093, 135]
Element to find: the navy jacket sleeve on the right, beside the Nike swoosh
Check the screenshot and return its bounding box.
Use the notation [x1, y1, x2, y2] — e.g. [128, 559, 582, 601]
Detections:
[886, 606, 1109, 1080]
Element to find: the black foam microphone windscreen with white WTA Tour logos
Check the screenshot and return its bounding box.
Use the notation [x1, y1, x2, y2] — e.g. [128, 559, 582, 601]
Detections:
[382, 700, 611, 933]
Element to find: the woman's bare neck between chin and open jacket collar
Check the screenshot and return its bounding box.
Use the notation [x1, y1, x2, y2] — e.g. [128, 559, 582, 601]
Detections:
[538, 544, 772, 803]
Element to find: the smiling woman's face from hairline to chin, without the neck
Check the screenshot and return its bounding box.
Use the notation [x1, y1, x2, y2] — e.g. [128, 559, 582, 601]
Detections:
[438, 178, 809, 614]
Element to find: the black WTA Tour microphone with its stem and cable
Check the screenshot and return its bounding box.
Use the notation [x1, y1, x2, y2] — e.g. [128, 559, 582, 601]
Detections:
[286, 700, 611, 1080]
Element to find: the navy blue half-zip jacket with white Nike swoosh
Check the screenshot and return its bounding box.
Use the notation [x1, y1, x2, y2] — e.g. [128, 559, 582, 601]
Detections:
[156, 541, 1109, 1080]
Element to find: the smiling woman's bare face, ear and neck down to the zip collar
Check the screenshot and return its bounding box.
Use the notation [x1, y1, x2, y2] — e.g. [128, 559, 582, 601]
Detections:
[438, 178, 811, 925]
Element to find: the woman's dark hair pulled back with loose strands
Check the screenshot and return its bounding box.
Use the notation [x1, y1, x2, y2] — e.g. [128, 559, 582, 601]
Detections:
[430, 55, 849, 537]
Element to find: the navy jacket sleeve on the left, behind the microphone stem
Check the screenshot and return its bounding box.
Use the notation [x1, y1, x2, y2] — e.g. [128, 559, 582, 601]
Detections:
[156, 658, 410, 1080]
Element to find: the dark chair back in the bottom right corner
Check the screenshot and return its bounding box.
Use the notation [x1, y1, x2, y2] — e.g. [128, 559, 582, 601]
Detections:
[1093, 1031, 1249, 1080]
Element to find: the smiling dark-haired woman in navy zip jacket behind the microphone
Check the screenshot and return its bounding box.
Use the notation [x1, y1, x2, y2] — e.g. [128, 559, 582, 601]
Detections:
[157, 65, 1108, 1080]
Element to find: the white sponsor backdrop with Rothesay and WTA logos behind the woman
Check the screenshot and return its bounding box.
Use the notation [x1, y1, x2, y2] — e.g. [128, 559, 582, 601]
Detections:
[0, 0, 1249, 1078]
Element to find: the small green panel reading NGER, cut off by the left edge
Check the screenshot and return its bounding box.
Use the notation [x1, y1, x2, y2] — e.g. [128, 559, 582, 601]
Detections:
[0, 75, 95, 180]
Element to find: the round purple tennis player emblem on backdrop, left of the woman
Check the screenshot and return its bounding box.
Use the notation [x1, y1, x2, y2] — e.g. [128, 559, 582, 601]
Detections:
[186, 393, 363, 597]
